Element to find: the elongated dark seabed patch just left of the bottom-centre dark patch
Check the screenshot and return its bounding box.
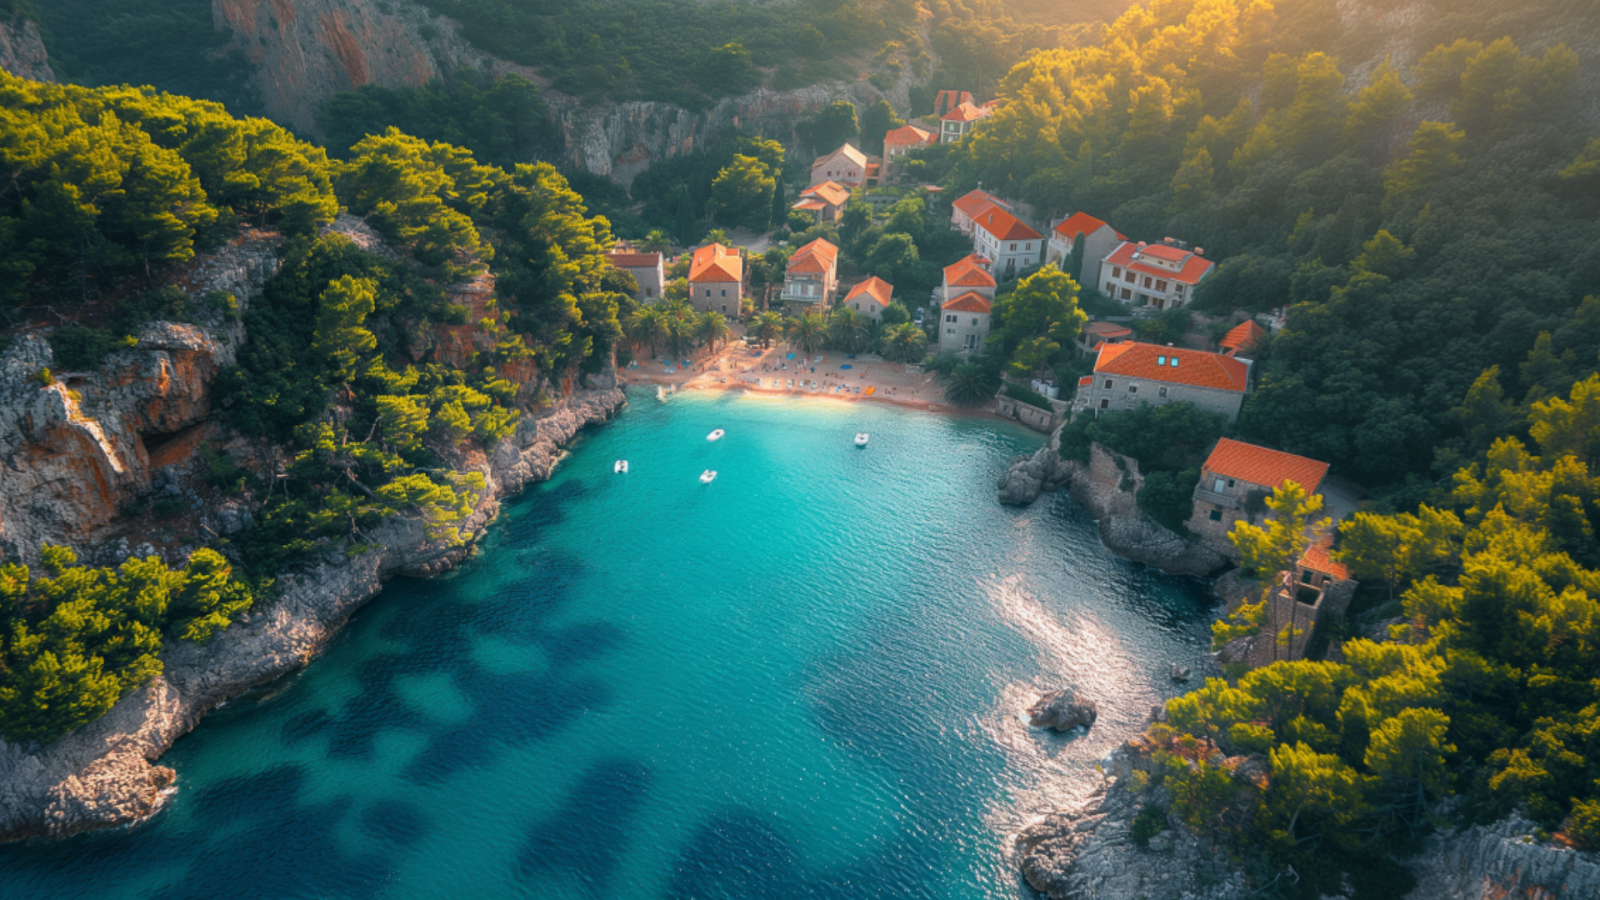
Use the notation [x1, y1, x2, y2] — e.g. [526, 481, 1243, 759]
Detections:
[517, 759, 651, 895]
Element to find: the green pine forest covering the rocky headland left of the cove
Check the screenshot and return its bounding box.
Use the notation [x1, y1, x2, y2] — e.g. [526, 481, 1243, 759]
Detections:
[0, 74, 634, 740]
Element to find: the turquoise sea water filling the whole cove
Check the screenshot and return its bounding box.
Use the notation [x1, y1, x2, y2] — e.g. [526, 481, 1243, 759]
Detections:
[0, 392, 1213, 900]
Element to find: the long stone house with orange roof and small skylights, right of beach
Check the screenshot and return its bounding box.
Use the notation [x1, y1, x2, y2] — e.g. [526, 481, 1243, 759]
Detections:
[1074, 341, 1250, 421]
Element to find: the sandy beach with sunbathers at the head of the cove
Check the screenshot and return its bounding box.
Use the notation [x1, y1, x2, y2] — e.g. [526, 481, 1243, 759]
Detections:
[618, 328, 984, 415]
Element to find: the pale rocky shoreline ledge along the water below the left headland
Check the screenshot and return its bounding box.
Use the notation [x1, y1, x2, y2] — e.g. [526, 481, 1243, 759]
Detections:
[0, 384, 624, 841]
